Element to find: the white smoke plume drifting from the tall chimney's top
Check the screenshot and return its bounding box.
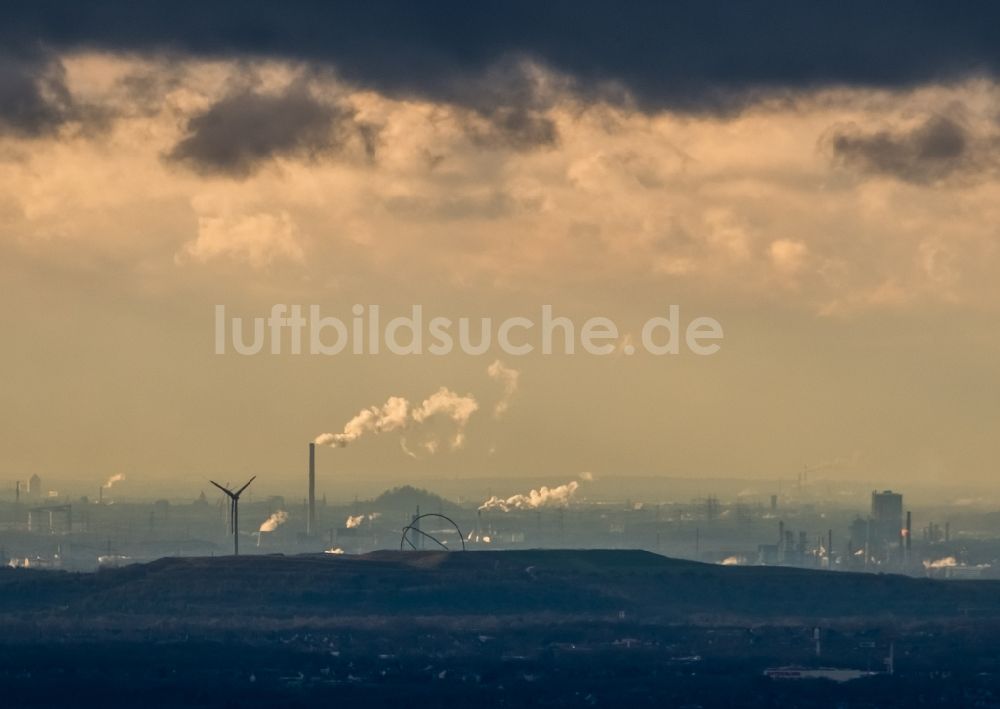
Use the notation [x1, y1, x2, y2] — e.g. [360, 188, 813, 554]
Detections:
[315, 387, 479, 455]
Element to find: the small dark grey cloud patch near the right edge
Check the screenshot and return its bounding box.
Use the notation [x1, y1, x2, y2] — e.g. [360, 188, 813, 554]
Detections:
[829, 116, 989, 182]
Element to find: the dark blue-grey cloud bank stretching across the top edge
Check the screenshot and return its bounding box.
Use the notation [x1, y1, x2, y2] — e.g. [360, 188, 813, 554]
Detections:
[0, 0, 1000, 112]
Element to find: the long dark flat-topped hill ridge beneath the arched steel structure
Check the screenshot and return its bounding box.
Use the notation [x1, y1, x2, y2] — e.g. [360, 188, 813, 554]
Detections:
[0, 549, 1000, 620]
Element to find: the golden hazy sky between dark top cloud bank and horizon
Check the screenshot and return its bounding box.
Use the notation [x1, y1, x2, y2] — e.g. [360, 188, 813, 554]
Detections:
[0, 52, 1000, 495]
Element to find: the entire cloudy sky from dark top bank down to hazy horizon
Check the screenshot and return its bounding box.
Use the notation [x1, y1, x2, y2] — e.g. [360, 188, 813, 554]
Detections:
[0, 2, 1000, 497]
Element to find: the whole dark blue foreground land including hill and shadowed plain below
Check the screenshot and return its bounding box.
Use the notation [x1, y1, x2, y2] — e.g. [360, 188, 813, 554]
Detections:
[0, 551, 1000, 707]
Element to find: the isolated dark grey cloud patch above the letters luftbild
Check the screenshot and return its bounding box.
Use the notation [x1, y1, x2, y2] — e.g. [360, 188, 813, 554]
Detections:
[167, 82, 377, 177]
